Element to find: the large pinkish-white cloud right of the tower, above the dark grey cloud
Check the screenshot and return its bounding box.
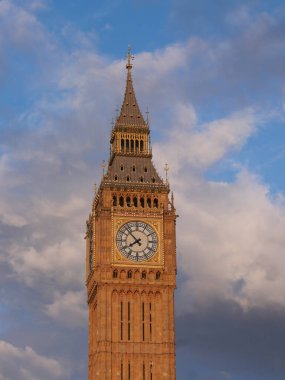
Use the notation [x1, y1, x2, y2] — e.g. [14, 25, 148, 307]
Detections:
[155, 103, 285, 312]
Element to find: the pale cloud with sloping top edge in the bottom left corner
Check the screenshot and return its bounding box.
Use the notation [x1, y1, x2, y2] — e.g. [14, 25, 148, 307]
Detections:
[0, 340, 67, 380]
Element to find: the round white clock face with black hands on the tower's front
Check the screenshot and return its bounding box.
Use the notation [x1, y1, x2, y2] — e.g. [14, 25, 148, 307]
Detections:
[116, 222, 158, 261]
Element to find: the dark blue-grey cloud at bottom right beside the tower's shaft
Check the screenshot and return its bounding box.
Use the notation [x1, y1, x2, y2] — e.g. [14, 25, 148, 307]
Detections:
[176, 302, 285, 380]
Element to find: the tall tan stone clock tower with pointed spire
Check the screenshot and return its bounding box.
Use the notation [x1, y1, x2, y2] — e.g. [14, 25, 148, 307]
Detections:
[86, 50, 176, 380]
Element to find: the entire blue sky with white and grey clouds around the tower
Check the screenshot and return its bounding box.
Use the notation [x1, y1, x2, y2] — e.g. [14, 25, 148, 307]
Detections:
[0, 0, 285, 380]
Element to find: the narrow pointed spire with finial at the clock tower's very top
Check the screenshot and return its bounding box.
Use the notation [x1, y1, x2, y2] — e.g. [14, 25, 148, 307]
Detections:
[116, 46, 147, 127]
